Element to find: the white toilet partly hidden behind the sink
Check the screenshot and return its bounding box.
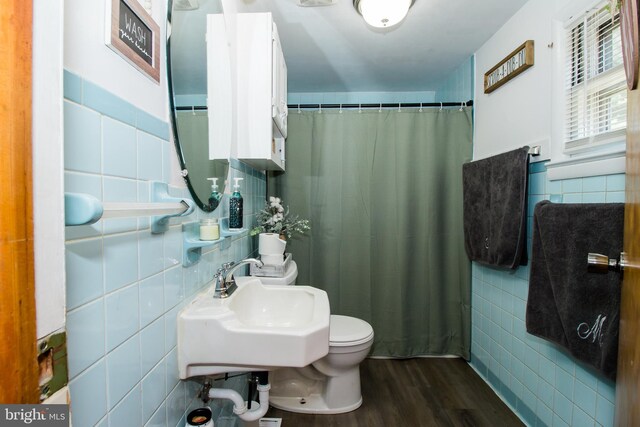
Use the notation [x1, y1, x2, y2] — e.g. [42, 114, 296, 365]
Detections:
[255, 261, 373, 414]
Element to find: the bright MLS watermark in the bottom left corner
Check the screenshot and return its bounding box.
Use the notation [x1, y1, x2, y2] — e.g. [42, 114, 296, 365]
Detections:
[0, 405, 69, 427]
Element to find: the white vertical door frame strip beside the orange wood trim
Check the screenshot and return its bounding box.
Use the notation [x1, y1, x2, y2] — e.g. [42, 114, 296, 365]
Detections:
[32, 0, 65, 338]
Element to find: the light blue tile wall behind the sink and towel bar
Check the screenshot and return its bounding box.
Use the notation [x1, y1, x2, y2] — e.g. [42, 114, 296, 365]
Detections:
[64, 71, 266, 427]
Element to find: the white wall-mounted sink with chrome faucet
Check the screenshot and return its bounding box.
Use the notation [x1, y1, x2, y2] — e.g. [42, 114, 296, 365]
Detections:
[178, 277, 330, 379]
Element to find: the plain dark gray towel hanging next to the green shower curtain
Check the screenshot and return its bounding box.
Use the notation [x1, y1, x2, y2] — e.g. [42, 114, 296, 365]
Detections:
[462, 147, 529, 269]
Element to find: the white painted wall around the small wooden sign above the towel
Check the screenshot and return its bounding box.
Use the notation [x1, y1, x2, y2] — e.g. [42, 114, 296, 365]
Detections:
[473, 0, 570, 160]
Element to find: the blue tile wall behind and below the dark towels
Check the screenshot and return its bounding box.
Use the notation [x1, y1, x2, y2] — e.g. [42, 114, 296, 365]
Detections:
[471, 163, 625, 427]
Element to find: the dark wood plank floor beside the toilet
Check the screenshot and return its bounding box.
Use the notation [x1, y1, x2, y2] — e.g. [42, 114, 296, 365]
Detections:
[266, 358, 524, 427]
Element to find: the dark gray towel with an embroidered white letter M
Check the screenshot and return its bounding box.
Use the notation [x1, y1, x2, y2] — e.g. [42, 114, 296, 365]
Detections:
[526, 201, 624, 379]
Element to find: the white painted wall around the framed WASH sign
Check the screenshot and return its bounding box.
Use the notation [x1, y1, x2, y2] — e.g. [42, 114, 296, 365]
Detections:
[64, 0, 167, 120]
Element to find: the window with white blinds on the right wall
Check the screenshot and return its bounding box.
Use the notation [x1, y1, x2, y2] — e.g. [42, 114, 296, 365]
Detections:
[564, 6, 627, 153]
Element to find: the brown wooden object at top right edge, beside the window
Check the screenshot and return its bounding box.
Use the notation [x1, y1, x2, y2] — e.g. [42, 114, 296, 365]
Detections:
[620, 0, 640, 90]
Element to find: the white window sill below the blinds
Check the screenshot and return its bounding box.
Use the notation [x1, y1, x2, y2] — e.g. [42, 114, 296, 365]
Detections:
[546, 149, 626, 181]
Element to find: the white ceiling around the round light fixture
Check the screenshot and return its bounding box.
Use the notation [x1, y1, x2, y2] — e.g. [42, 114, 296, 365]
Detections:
[174, 0, 527, 93]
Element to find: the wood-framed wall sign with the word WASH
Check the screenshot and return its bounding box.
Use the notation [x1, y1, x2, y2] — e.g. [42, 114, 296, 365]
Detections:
[105, 0, 160, 83]
